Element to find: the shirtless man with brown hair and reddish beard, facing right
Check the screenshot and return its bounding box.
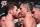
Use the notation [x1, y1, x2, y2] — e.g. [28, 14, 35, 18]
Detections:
[0, 2, 18, 27]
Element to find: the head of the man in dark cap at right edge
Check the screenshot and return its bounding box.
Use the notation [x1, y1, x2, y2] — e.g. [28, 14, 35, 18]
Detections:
[32, 4, 40, 23]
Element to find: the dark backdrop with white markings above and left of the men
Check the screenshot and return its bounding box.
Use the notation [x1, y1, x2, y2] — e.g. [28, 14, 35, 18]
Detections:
[0, 0, 40, 17]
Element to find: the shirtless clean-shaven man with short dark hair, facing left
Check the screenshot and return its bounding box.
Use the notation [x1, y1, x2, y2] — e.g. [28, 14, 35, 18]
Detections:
[20, 1, 36, 27]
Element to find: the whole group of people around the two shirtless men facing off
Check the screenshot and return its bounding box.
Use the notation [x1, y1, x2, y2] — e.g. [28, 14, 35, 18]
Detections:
[0, 1, 40, 27]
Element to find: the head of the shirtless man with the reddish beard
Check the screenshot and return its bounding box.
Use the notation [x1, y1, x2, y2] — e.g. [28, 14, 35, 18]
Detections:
[5, 2, 18, 17]
